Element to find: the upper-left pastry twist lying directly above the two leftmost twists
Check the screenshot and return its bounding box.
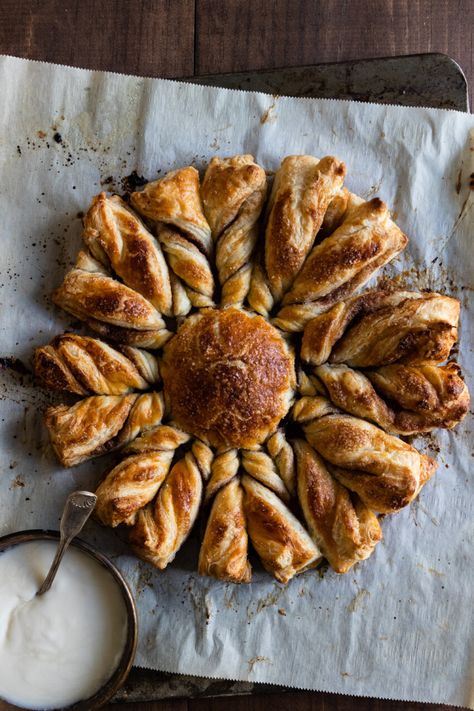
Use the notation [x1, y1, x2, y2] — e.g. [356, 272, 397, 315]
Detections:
[53, 252, 172, 348]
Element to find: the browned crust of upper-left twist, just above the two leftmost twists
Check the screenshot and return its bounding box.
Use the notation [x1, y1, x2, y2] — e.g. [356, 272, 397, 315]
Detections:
[53, 252, 169, 342]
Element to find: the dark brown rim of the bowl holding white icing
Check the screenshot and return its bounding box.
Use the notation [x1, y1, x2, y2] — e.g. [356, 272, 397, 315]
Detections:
[0, 528, 138, 711]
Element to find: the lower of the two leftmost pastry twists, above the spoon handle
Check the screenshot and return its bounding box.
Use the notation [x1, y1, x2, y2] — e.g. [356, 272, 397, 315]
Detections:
[45, 393, 164, 467]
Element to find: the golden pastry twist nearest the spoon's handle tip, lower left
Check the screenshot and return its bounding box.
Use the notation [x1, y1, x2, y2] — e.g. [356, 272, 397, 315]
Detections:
[94, 425, 189, 527]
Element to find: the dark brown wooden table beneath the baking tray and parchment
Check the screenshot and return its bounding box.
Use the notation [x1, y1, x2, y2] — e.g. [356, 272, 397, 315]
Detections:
[0, 0, 474, 711]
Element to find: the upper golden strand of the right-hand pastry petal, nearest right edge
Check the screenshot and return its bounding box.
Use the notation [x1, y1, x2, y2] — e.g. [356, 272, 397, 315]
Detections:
[329, 293, 460, 368]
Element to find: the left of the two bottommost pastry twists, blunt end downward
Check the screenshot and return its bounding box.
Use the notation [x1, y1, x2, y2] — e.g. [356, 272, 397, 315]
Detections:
[198, 478, 251, 583]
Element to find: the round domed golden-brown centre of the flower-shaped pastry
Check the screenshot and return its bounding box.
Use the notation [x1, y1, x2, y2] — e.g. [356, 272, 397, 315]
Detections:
[162, 308, 296, 447]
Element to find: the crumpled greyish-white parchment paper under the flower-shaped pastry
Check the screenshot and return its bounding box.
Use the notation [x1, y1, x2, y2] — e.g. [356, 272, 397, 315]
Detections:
[0, 57, 474, 708]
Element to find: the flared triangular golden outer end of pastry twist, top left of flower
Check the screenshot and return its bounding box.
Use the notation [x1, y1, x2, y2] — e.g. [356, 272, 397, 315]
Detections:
[130, 166, 212, 256]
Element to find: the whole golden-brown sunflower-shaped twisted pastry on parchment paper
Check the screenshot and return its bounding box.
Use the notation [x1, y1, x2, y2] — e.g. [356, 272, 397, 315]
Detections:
[34, 154, 469, 583]
